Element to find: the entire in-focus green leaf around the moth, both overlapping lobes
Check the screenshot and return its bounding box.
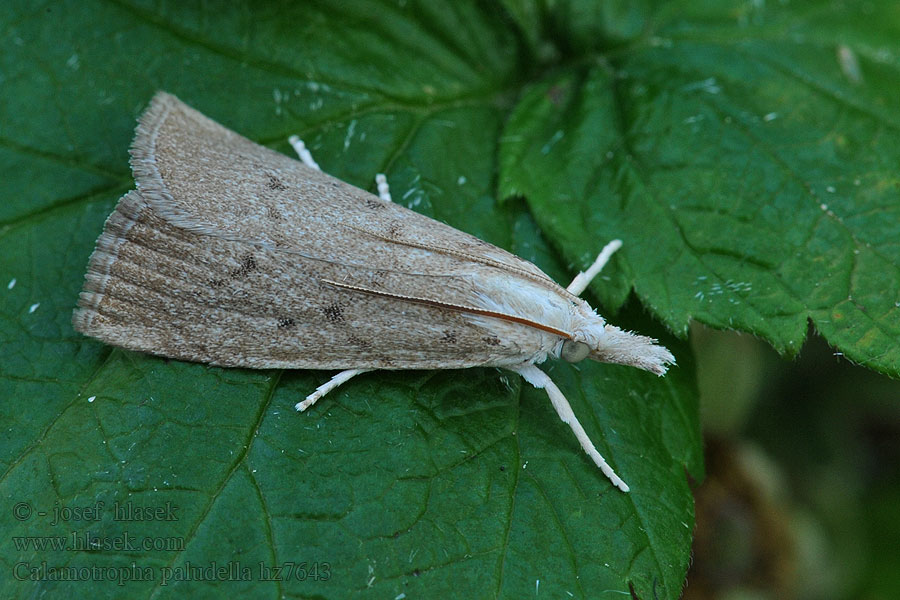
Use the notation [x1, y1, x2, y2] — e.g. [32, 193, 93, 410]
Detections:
[0, 0, 898, 598]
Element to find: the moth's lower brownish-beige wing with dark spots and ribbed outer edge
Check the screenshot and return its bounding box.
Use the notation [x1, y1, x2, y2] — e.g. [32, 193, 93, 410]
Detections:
[73, 191, 552, 369]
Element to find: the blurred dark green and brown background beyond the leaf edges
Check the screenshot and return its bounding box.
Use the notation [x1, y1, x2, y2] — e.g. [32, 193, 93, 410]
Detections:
[684, 325, 900, 600]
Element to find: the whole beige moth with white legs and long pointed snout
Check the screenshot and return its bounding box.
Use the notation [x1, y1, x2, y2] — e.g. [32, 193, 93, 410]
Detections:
[73, 92, 675, 491]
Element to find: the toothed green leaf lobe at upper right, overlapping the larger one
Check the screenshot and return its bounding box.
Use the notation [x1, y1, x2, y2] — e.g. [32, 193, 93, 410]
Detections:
[500, 2, 900, 376]
